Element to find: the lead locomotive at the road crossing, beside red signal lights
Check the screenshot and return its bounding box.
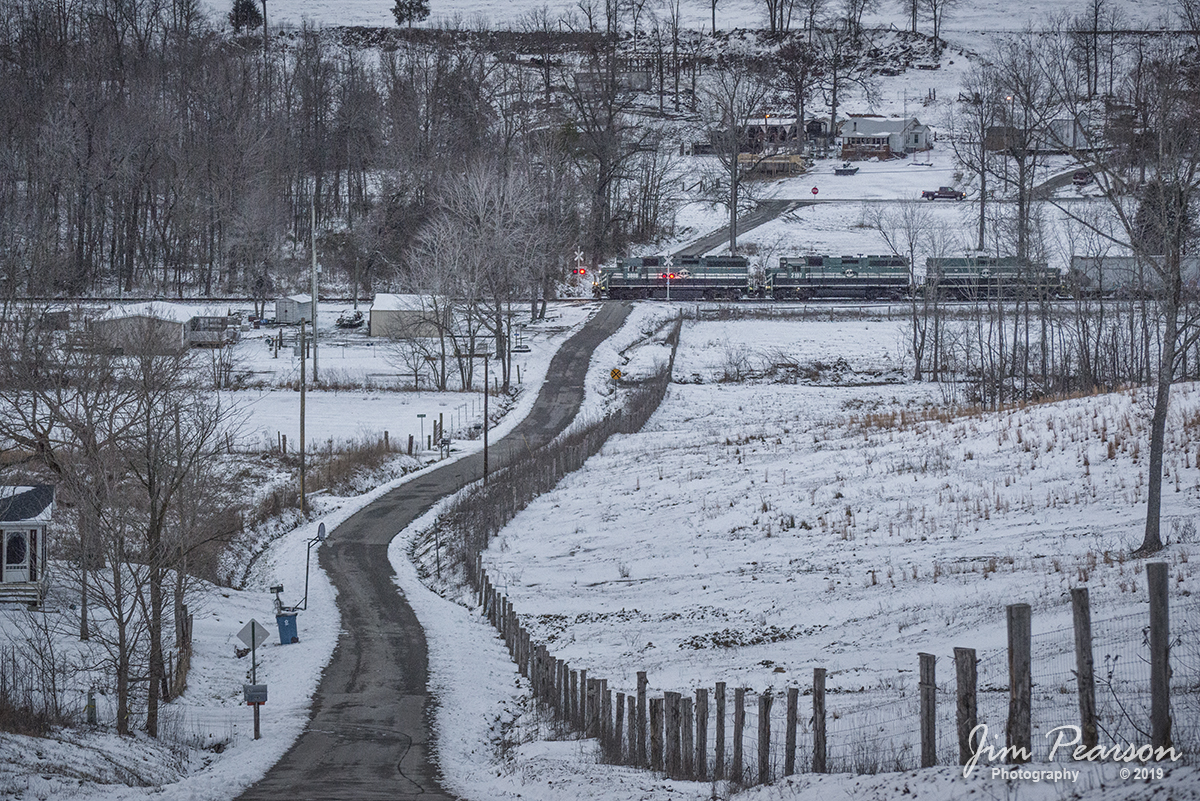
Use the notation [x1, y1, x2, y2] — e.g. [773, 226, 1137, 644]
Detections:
[593, 255, 755, 300]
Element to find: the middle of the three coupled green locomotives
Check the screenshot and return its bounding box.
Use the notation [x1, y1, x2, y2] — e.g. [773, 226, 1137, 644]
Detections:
[763, 255, 911, 300]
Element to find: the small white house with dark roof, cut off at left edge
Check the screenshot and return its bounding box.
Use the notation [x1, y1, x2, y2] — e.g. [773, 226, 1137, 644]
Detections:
[0, 484, 54, 607]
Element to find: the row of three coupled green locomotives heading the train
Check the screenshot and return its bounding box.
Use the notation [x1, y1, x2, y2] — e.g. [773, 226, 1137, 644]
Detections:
[592, 255, 1062, 301]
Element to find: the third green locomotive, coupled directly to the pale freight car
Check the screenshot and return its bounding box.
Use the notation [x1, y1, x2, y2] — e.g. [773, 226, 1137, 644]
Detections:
[925, 255, 1062, 300]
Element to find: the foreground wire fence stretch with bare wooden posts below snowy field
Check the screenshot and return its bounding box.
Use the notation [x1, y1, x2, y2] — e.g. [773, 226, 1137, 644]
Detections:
[479, 575, 1200, 787]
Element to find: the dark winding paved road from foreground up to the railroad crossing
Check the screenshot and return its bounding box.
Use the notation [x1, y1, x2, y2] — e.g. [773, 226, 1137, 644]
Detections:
[231, 303, 629, 801]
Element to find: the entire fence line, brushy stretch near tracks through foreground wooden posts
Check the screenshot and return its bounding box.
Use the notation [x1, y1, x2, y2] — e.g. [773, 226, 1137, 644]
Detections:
[417, 320, 1200, 785]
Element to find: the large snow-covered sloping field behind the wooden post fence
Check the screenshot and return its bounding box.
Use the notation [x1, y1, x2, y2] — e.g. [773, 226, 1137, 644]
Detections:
[453, 320, 1200, 797]
